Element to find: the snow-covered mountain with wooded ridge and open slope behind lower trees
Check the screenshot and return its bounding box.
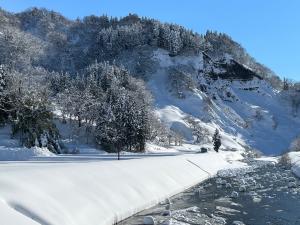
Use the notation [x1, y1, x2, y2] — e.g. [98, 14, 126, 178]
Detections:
[0, 8, 300, 154]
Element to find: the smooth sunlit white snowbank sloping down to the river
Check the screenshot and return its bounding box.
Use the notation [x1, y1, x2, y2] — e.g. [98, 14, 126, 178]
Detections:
[0, 152, 245, 225]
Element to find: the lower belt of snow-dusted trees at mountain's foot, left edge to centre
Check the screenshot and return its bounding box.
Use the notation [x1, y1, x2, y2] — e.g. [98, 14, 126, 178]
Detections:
[0, 63, 171, 153]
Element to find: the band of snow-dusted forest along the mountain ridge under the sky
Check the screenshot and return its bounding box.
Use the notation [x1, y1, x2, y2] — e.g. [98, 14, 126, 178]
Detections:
[0, 8, 282, 87]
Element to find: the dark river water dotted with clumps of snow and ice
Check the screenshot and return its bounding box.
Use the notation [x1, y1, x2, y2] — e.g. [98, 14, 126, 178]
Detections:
[119, 161, 300, 225]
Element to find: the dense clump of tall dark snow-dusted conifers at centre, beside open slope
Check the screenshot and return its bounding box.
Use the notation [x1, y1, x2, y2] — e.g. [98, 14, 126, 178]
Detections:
[89, 64, 152, 156]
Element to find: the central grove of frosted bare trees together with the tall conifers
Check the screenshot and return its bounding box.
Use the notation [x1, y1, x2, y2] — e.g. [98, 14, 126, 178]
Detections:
[49, 63, 165, 151]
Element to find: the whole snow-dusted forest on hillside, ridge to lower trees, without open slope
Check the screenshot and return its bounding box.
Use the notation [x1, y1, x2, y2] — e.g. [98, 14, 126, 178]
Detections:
[0, 8, 293, 153]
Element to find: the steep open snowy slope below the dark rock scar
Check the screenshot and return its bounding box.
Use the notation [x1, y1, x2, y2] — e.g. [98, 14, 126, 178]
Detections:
[148, 50, 300, 155]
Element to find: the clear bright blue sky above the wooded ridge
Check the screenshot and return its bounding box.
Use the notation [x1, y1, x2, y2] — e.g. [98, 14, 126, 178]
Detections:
[0, 0, 300, 80]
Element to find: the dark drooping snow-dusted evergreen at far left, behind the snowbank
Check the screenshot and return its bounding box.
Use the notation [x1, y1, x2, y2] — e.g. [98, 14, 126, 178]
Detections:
[11, 91, 60, 153]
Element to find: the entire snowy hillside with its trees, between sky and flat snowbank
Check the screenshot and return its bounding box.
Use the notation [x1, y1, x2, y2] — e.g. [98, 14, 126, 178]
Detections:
[0, 8, 300, 155]
